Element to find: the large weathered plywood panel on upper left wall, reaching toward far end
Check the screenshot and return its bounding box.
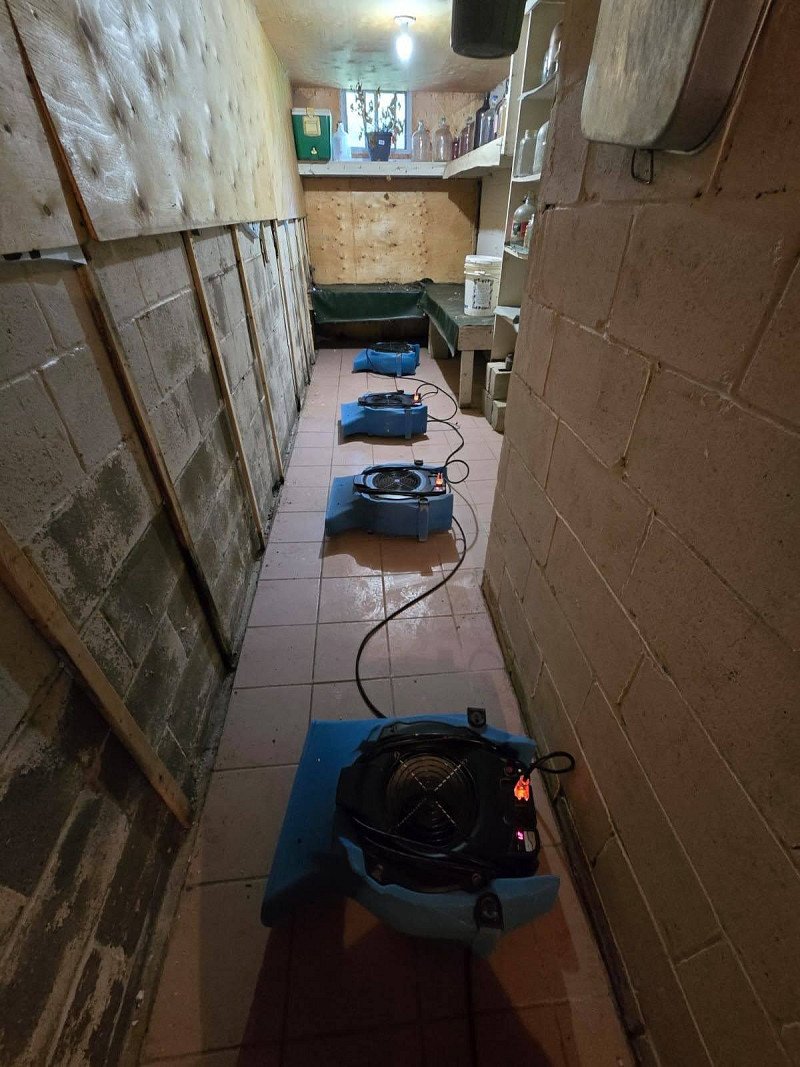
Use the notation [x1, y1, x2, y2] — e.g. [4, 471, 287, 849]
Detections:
[11, 0, 302, 240]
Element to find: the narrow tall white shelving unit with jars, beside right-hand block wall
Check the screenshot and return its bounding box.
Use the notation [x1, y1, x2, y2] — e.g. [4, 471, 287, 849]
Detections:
[492, 0, 564, 360]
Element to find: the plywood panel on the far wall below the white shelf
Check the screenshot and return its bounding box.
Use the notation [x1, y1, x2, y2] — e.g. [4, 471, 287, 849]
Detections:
[306, 178, 478, 284]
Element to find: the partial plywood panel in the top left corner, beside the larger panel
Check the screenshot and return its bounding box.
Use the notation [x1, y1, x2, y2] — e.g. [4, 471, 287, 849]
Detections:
[0, 3, 78, 254]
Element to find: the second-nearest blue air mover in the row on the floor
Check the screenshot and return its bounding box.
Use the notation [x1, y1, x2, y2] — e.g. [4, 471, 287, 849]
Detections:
[325, 460, 452, 541]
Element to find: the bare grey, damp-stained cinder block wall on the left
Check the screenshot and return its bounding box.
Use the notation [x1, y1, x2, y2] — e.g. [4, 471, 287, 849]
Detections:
[0, 220, 305, 1065]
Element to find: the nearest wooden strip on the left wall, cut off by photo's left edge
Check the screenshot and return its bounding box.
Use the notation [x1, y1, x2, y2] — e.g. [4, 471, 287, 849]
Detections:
[0, 522, 191, 827]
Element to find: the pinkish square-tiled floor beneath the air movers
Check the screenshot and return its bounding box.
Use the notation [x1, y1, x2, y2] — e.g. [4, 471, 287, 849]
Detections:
[143, 350, 631, 1067]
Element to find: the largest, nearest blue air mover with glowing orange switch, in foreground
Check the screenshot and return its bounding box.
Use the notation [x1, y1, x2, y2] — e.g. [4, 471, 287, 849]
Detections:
[261, 708, 559, 955]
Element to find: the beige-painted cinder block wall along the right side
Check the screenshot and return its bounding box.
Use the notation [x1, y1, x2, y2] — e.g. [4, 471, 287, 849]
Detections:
[485, 0, 800, 1067]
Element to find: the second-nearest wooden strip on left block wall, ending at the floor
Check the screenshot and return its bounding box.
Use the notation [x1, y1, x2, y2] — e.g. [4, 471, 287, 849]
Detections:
[76, 261, 236, 667]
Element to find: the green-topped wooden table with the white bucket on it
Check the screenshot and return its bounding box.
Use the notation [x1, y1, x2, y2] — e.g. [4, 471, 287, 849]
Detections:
[419, 284, 495, 408]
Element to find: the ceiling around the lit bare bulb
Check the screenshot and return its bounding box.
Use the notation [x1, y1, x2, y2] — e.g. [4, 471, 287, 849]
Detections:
[255, 0, 509, 92]
